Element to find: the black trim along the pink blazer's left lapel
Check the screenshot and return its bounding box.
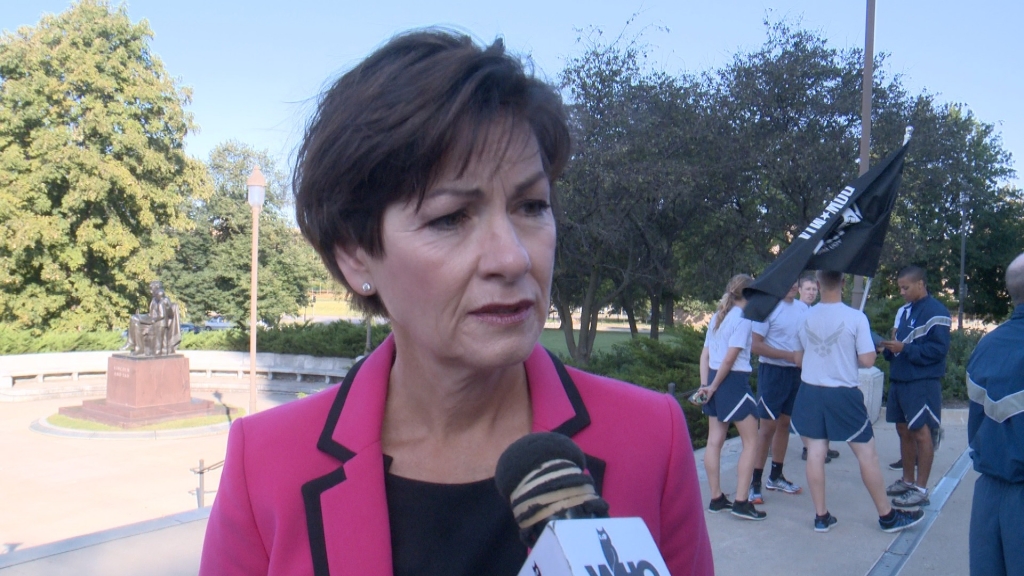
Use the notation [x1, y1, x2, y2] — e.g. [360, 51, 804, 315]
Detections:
[302, 359, 366, 576]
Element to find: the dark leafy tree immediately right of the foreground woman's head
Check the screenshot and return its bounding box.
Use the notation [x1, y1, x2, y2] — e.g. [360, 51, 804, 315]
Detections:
[552, 35, 689, 363]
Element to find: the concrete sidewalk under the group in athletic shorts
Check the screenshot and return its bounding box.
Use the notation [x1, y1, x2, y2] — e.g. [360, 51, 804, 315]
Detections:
[695, 410, 974, 576]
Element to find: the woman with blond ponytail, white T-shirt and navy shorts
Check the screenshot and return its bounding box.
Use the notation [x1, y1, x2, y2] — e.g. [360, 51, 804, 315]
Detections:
[697, 274, 768, 520]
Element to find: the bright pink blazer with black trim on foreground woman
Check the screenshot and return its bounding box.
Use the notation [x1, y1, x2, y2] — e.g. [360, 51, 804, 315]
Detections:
[200, 338, 714, 576]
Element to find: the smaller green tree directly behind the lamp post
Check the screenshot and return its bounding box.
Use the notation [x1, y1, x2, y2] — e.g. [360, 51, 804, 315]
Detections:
[162, 141, 323, 326]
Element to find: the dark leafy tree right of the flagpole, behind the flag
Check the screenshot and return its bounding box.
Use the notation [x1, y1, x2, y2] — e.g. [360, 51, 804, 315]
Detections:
[880, 100, 1024, 319]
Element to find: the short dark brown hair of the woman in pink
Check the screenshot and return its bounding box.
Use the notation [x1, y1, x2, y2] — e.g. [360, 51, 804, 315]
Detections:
[292, 30, 569, 315]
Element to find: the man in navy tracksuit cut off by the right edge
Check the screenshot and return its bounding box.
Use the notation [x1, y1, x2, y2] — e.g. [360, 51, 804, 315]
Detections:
[967, 254, 1024, 576]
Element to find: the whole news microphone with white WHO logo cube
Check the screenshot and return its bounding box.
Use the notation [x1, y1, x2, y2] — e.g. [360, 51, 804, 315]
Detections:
[495, 433, 670, 576]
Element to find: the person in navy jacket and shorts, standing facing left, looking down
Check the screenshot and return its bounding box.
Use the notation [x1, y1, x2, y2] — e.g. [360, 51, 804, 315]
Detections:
[881, 265, 952, 507]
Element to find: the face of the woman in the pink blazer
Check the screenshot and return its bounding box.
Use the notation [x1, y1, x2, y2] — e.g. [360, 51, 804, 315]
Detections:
[339, 124, 555, 368]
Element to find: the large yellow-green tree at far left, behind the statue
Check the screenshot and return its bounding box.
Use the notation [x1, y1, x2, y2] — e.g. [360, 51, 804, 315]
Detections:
[0, 0, 209, 330]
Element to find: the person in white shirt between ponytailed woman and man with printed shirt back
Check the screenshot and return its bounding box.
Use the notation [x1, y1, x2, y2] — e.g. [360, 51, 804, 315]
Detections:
[749, 283, 817, 504]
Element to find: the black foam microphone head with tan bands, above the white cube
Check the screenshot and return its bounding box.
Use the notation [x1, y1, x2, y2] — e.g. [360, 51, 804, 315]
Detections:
[495, 433, 608, 547]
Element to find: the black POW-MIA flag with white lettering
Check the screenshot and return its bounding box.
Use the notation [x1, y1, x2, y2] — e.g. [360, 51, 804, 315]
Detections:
[743, 137, 909, 322]
